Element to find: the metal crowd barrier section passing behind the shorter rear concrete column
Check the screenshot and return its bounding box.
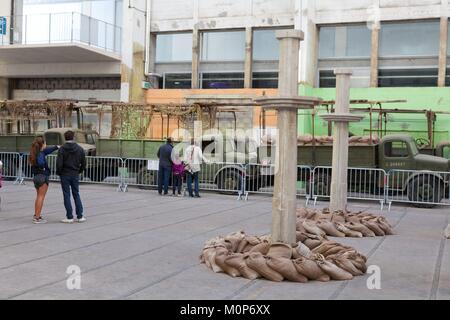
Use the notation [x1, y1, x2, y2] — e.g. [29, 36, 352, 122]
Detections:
[310, 166, 387, 210]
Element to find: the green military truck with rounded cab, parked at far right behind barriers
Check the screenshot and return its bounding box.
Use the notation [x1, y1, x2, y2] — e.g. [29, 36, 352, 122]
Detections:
[256, 135, 450, 207]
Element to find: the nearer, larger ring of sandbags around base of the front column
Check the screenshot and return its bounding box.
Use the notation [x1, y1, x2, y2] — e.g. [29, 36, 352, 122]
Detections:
[200, 231, 367, 283]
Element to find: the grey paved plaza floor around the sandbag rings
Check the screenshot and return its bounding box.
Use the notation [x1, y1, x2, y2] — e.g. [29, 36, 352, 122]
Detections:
[0, 182, 450, 300]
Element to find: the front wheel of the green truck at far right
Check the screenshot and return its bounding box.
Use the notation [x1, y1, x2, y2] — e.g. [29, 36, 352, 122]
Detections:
[407, 176, 444, 208]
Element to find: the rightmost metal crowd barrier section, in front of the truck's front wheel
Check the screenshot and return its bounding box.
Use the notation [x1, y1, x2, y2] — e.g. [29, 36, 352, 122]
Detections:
[386, 170, 450, 209]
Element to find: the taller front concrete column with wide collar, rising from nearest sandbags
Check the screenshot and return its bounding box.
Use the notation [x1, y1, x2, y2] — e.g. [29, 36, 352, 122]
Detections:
[256, 30, 320, 243]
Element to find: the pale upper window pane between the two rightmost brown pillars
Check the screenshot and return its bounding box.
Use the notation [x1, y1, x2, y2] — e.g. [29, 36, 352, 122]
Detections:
[380, 21, 439, 57]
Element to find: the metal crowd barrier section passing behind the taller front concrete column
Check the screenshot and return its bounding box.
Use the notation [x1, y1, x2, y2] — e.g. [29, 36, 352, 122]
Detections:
[245, 164, 311, 205]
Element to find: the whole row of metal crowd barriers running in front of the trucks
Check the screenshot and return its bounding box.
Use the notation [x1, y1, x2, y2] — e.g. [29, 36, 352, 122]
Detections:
[0, 152, 450, 210]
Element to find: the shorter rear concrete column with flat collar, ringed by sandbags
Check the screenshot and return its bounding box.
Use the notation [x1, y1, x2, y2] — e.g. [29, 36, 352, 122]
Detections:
[322, 69, 363, 212]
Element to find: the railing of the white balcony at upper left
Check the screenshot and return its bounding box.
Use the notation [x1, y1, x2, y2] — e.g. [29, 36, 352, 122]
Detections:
[0, 12, 122, 53]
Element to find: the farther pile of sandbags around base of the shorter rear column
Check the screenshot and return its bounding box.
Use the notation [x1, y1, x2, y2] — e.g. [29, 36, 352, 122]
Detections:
[296, 208, 394, 240]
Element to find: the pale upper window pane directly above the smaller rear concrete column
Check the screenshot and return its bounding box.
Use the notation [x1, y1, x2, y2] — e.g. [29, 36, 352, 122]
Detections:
[319, 25, 371, 59]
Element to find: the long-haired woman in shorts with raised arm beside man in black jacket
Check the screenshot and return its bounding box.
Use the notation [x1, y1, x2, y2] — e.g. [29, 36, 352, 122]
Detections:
[29, 137, 58, 224]
